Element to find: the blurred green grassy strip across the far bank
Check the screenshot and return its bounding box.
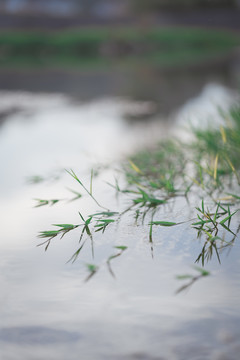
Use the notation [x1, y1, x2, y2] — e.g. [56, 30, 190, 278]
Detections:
[0, 28, 240, 68]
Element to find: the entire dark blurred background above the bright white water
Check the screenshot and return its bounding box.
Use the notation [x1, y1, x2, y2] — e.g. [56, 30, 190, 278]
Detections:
[0, 0, 240, 118]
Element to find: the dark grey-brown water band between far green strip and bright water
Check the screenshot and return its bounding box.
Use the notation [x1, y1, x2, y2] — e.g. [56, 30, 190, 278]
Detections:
[0, 52, 240, 114]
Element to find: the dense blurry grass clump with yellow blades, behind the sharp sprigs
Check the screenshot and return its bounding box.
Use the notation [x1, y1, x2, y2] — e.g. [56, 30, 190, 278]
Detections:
[125, 104, 240, 201]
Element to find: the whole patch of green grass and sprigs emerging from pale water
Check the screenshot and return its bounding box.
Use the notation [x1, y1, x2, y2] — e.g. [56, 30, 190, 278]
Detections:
[34, 106, 240, 292]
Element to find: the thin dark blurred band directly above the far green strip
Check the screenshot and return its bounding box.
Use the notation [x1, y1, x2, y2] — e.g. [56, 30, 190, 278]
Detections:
[0, 8, 240, 31]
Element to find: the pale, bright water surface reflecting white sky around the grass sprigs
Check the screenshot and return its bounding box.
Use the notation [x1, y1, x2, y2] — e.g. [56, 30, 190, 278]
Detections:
[0, 66, 240, 360]
